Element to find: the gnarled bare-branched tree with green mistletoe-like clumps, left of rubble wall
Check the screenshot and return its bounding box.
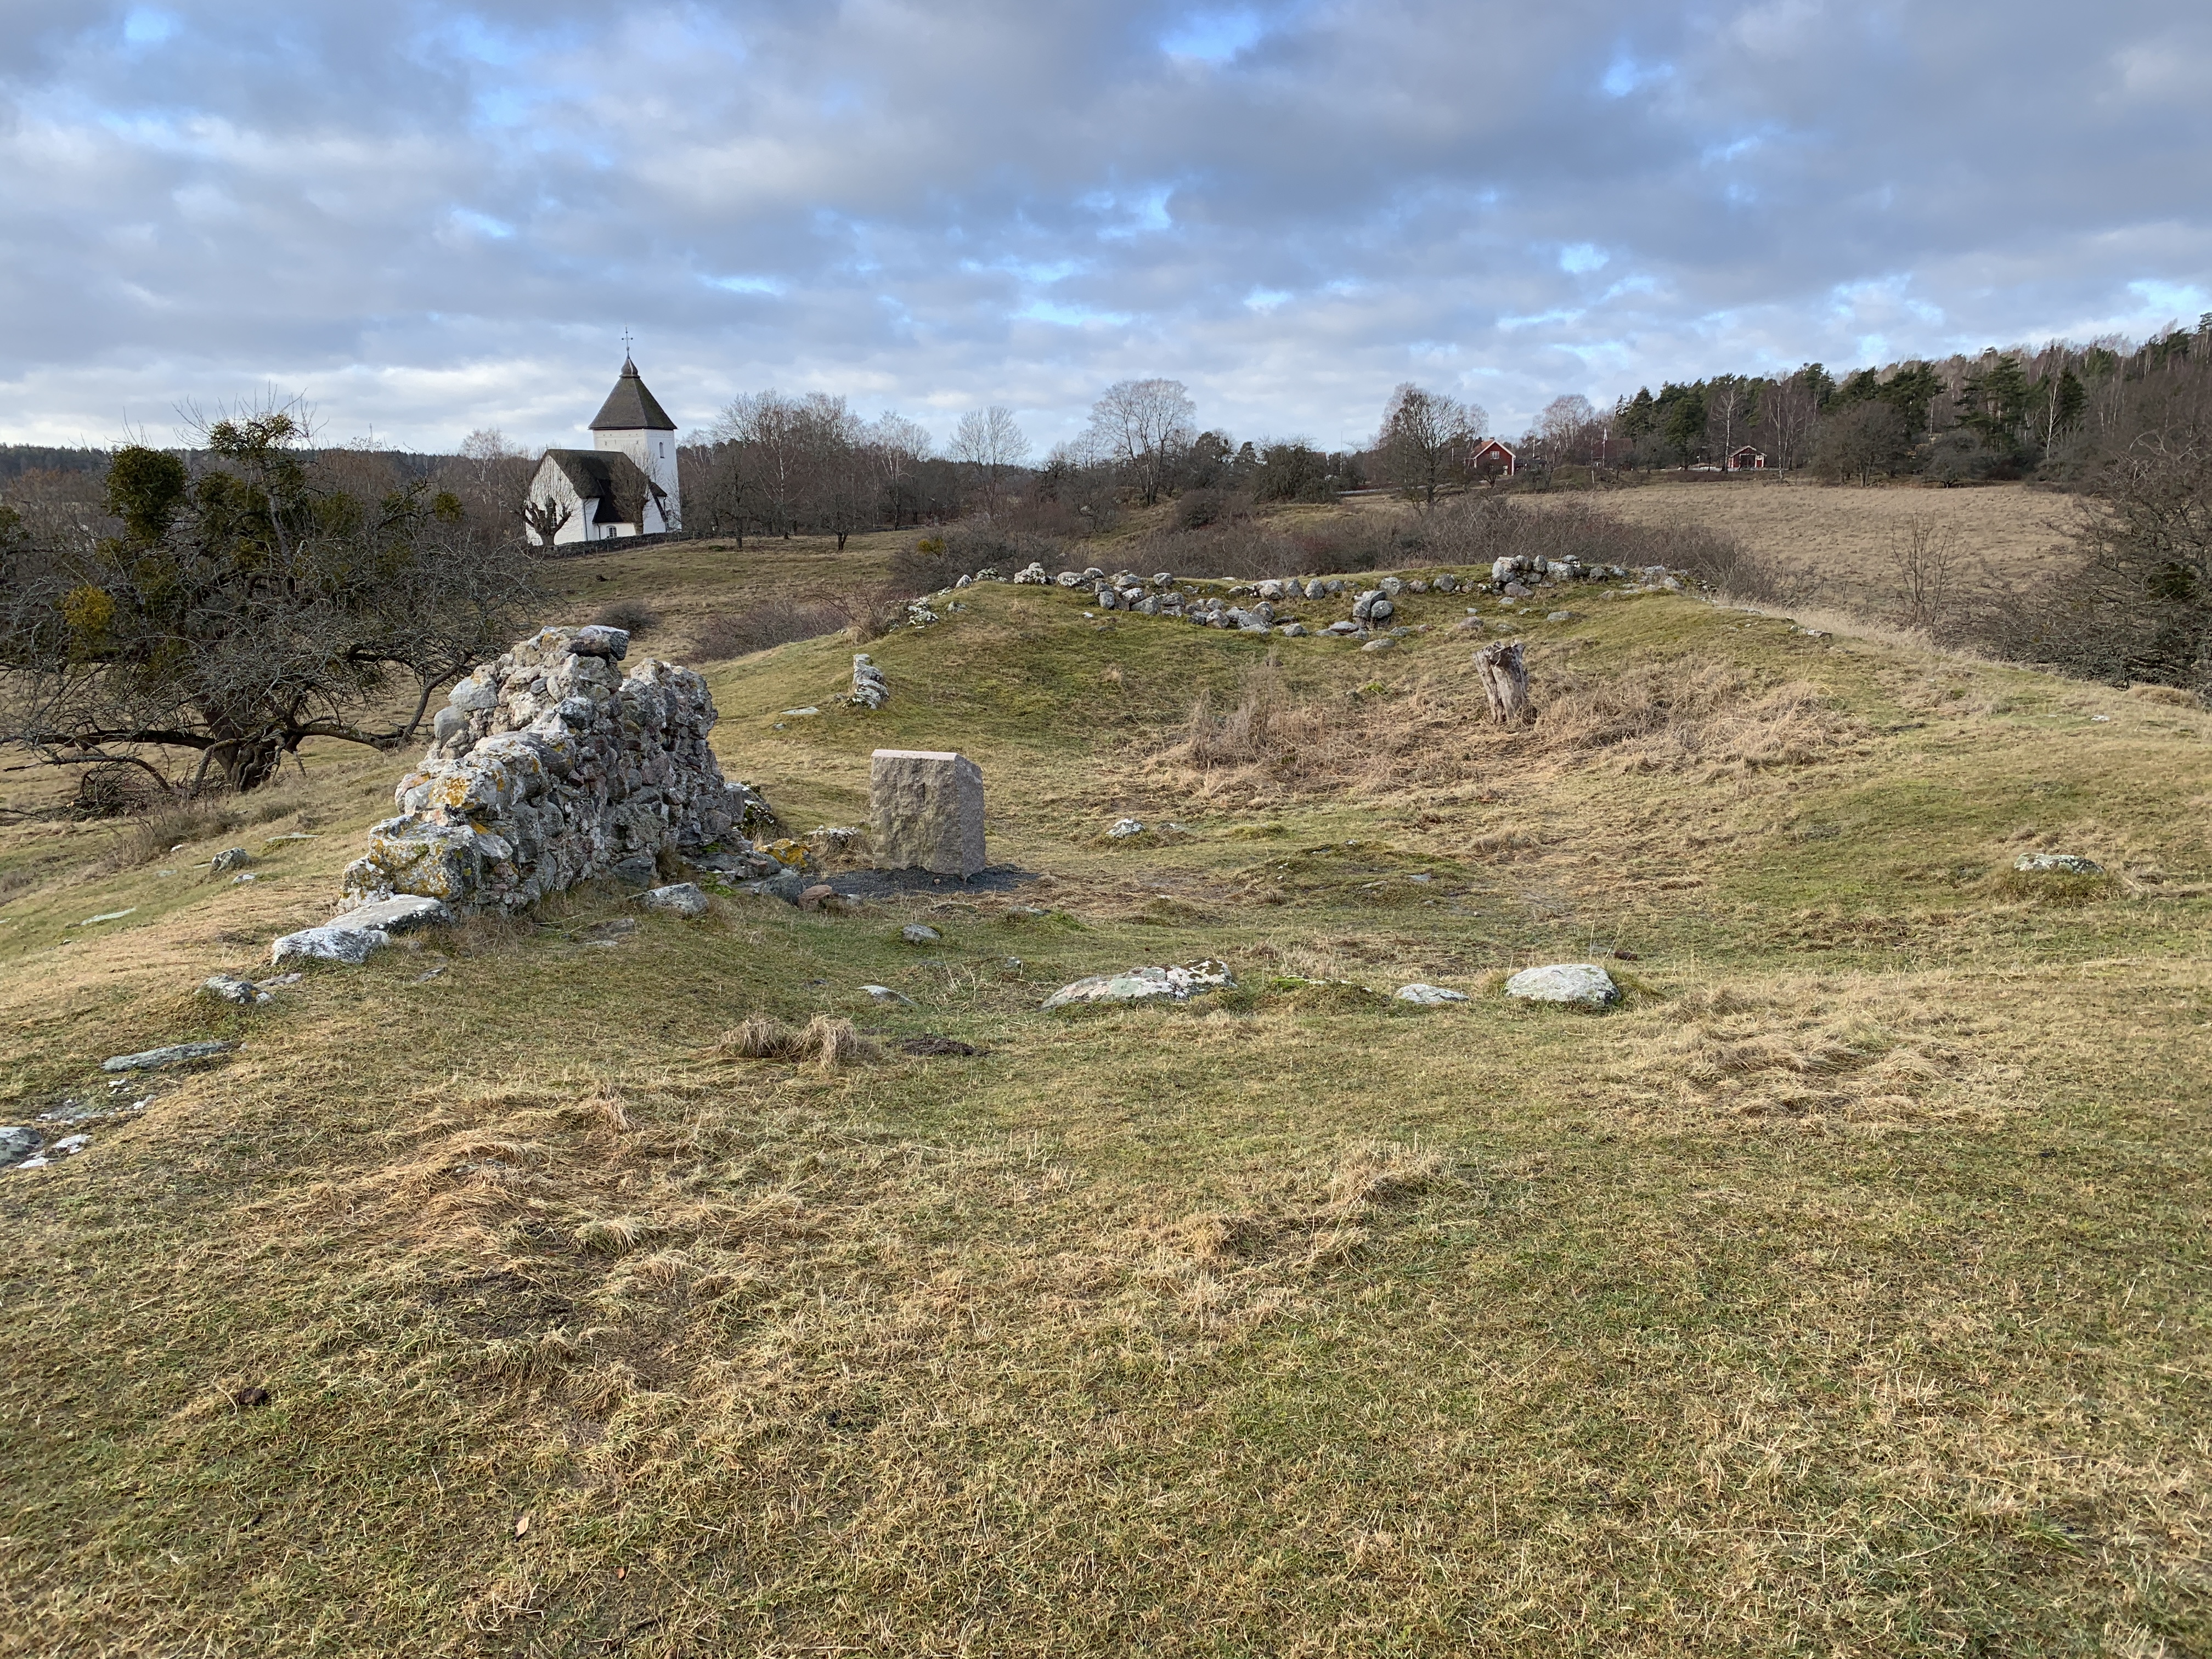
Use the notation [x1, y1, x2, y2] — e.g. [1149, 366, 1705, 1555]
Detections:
[0, 411, 538, 792]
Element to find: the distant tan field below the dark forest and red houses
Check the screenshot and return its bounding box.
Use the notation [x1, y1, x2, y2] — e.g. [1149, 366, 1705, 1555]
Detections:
[1524, 478, 2079, 613]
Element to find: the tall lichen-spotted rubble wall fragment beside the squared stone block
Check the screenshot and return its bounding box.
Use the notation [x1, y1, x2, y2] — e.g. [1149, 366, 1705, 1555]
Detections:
[343, 628, 774, 911]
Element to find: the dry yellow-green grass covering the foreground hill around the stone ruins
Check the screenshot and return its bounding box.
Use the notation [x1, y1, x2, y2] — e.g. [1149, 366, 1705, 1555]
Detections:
[0, 535, 2212, 1659]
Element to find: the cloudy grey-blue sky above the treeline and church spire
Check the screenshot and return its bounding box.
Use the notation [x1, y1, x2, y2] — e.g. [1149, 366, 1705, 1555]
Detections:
[0, 0, 2212, 452]
